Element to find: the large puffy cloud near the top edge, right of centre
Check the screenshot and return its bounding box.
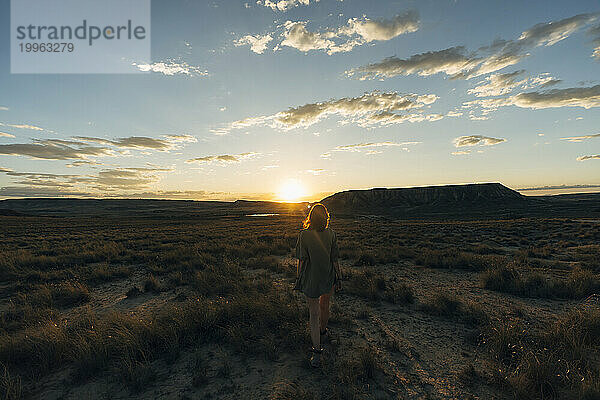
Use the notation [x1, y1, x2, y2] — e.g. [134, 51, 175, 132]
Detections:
[275, 11, 419, 55]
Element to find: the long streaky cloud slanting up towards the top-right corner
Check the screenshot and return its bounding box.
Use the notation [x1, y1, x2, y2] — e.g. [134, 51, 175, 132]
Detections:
[347, 14, 597, 79]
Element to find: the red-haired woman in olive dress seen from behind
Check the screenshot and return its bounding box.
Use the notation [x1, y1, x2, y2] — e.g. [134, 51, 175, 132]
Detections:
[296, 203, 341, 367]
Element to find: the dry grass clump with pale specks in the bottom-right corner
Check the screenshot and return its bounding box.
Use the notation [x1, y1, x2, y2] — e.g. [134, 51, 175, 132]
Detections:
[486, 308, 600, 399]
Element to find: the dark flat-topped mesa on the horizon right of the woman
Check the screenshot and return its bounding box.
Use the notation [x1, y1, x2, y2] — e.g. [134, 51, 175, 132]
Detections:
[321, 183, 600, 219]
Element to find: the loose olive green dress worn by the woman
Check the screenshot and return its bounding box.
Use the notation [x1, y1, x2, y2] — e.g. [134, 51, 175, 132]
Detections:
[296, 228, 339, 298]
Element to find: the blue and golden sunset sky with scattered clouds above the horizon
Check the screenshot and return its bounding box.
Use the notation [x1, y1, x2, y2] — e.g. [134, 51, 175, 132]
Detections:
[0, 0, 600, 200]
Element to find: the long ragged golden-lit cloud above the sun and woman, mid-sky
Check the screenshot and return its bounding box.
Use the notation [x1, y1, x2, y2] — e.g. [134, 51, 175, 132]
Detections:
[218, 91, 443, 134]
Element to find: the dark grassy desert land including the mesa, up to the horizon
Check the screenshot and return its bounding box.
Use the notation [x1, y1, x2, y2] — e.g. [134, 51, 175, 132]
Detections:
[0, 184, 600, 399]
